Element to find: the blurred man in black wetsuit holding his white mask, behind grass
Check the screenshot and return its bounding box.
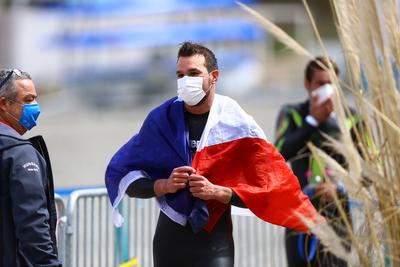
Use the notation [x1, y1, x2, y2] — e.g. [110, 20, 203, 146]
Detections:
[275, 57, 361, 267]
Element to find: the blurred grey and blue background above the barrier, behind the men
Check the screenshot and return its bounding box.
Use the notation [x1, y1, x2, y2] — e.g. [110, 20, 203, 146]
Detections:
[0, 0, 345, 192]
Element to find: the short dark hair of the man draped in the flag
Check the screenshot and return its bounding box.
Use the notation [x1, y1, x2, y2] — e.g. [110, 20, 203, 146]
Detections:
[178, 42, 218, 72]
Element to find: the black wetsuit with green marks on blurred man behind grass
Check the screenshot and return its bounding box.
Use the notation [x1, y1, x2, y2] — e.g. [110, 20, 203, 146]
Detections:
[275, 101, 360, 267]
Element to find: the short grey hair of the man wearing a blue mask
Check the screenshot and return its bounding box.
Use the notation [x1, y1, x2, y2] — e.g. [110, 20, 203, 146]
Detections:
[0, 69, 32, 101]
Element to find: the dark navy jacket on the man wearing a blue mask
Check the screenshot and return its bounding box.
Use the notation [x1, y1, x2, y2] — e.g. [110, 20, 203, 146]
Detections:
[0, 123, 61, 267]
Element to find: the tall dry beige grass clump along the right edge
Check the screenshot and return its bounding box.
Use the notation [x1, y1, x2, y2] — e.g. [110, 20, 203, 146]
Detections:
[240, 0, 400, 267]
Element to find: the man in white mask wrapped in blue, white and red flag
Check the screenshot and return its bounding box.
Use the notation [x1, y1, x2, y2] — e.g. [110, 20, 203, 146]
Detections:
[106, 42, 323, 267]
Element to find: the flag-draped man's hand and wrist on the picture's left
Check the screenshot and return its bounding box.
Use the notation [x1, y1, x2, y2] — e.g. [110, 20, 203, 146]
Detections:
[154, 166, 196, 197]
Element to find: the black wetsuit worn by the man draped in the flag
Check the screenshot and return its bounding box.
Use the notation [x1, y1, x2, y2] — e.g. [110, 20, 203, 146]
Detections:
[127, 112, 244, 267]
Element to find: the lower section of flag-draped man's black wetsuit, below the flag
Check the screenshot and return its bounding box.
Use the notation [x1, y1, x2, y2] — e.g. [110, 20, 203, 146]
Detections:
[153, 209, 234, 267]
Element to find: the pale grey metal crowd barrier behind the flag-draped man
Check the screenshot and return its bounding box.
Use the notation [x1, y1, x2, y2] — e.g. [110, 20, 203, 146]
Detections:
[56, 188, 286, 267]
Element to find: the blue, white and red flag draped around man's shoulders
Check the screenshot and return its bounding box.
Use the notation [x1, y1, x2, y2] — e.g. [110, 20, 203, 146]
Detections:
[105, 94, 323, 232]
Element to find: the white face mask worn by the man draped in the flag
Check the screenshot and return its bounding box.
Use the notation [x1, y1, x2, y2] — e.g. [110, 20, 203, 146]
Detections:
[177, 76, 206, 106]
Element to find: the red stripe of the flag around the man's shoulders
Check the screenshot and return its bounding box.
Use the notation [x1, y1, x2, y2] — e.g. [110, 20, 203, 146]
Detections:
[192, 138, 324, 232]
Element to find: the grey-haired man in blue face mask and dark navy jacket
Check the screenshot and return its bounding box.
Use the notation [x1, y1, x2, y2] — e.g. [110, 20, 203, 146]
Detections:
[0, 70, 61, 267]
